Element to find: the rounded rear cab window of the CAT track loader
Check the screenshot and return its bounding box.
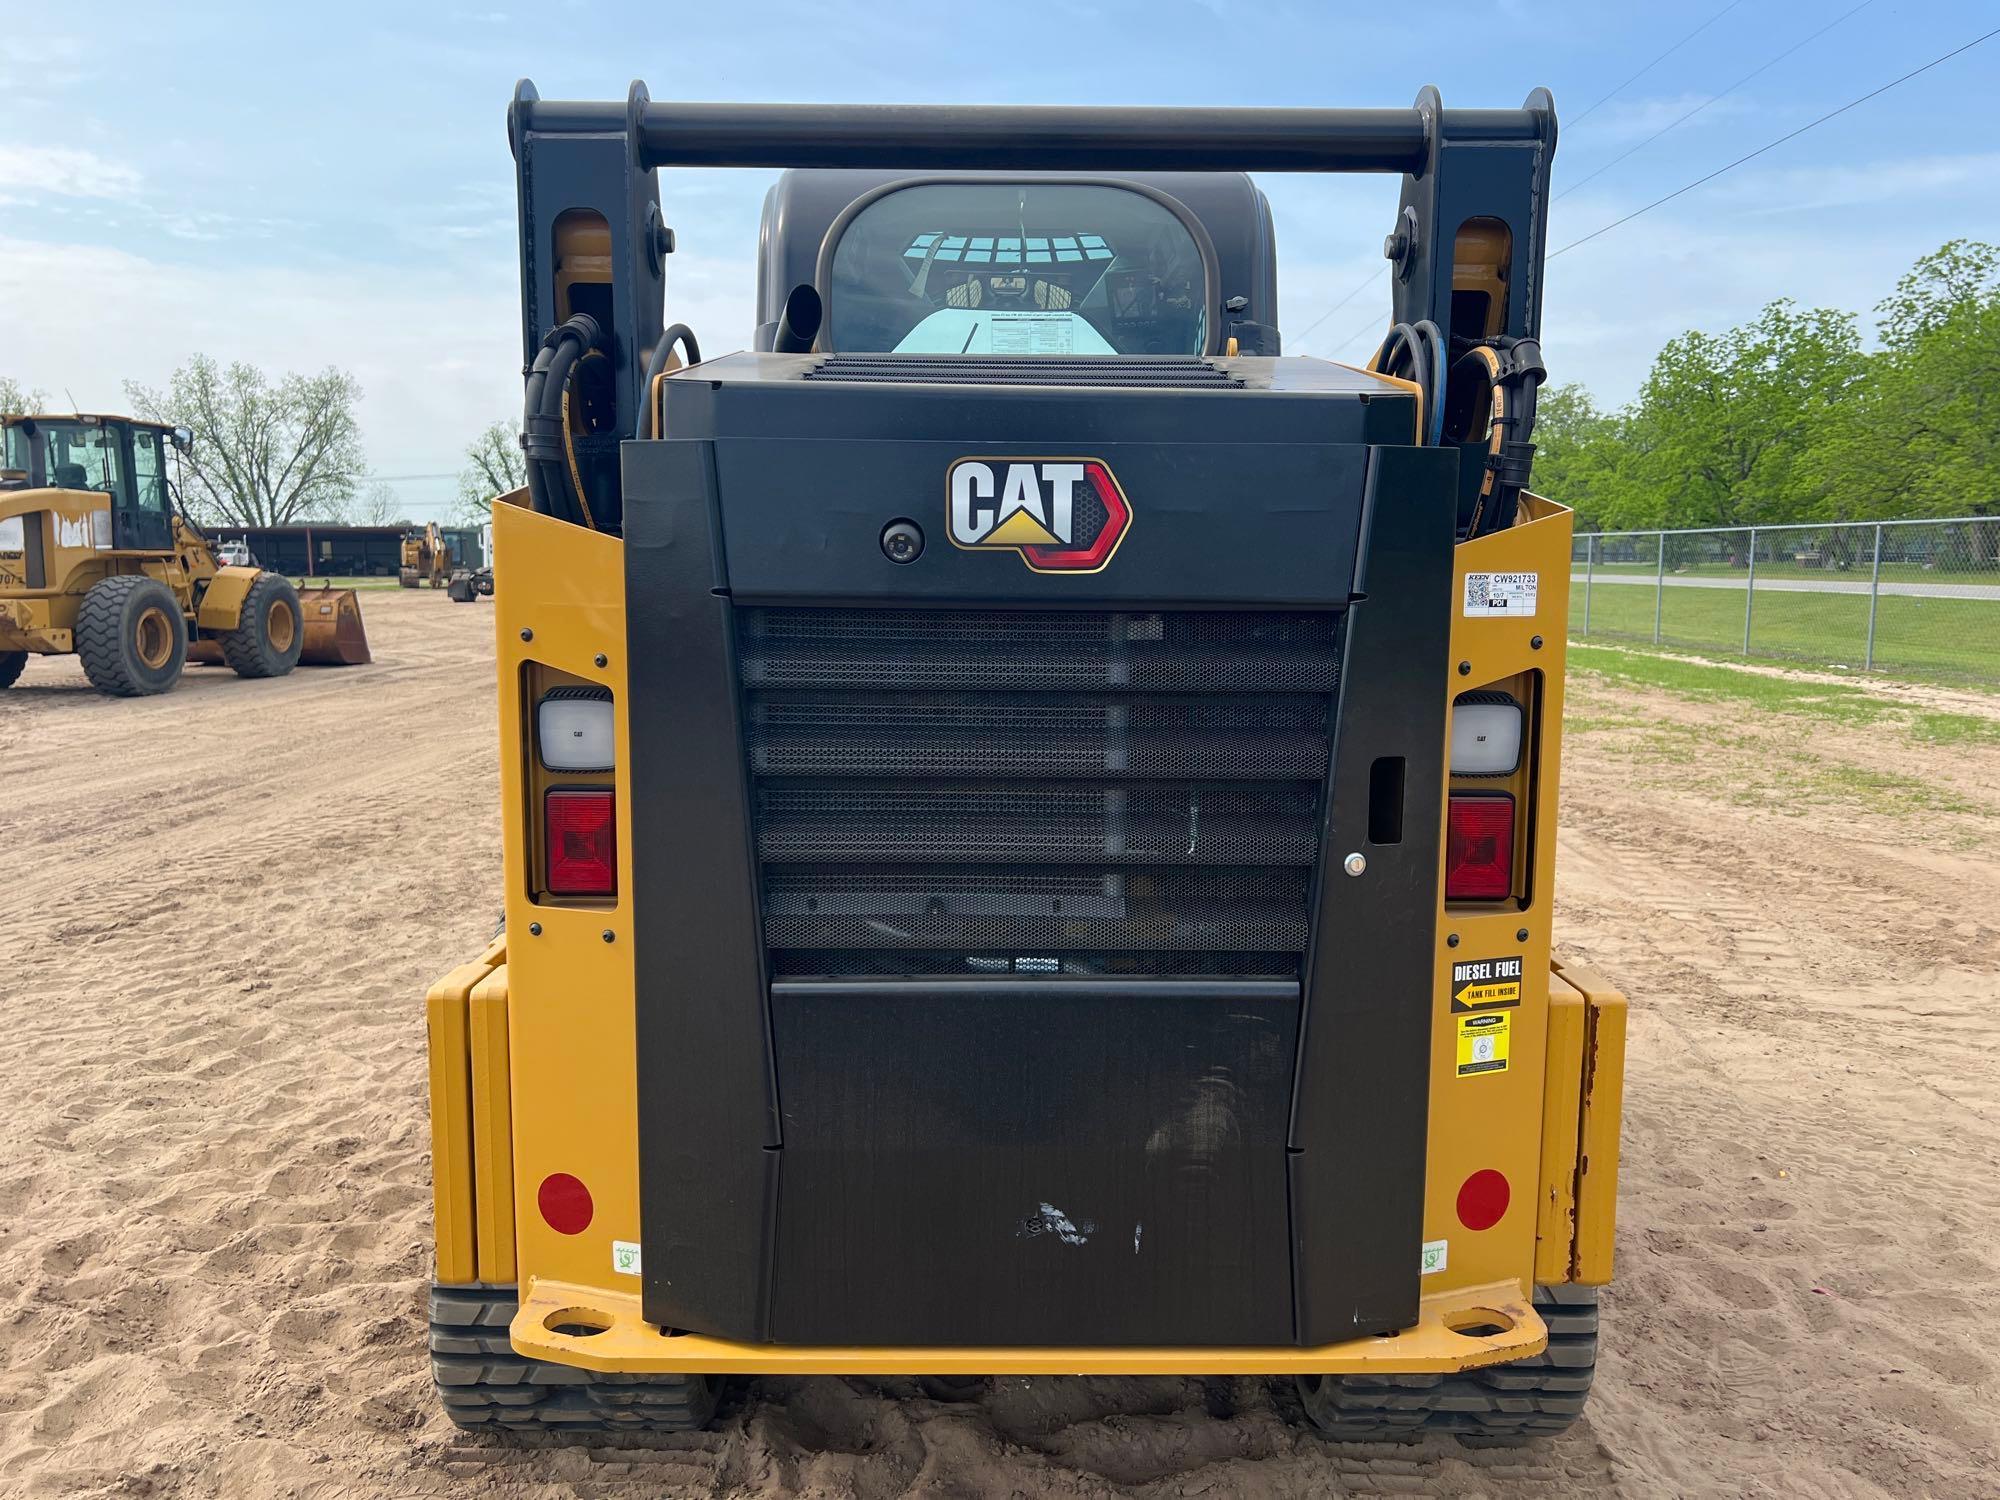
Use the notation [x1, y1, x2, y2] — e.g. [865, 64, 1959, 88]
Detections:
[826, 182, 1208, 354]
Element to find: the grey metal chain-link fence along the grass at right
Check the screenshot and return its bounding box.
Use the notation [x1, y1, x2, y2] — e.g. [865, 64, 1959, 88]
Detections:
[1570, 516, 2000, 686]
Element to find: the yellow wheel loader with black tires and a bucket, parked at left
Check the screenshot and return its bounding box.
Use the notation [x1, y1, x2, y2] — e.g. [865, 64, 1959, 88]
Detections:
[0, 416, 368, 698]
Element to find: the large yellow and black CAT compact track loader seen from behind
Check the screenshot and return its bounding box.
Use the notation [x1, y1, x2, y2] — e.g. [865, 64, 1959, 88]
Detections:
[428, 84, 1624, 1442]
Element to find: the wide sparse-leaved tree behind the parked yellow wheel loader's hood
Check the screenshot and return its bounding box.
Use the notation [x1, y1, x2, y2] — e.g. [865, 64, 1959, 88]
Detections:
[126, 354, 368, 526]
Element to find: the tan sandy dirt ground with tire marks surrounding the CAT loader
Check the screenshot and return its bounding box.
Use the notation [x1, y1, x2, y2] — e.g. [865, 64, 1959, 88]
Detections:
[0, 592, 2000, 1500]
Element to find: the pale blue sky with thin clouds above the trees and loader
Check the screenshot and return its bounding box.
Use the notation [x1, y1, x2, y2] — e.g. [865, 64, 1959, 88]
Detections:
[0, 0, 2000, 516]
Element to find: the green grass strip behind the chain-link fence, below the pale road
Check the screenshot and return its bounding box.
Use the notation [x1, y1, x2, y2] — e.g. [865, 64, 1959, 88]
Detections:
[1570, 584, 2000, 686]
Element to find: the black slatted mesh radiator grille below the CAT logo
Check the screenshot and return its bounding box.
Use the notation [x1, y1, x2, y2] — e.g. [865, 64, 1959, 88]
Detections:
[738, 610, 1340, 976]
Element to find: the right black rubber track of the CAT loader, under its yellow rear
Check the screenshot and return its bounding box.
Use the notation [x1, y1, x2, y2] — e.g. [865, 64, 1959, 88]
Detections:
[1296, 1286, 1598, 1448]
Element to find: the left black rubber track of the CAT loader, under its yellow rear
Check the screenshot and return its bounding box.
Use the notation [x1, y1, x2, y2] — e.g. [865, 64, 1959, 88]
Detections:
[430, 1286, 722, 1434]
